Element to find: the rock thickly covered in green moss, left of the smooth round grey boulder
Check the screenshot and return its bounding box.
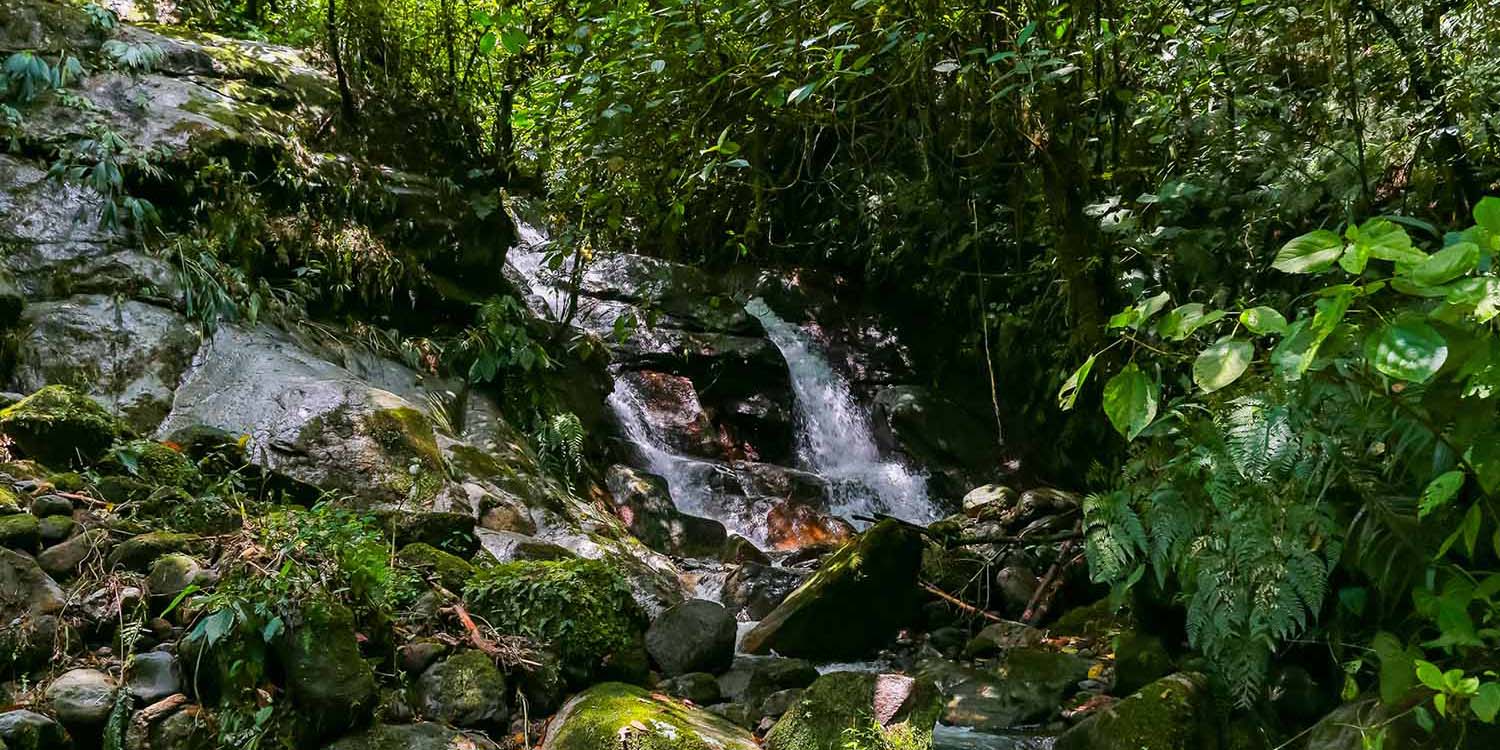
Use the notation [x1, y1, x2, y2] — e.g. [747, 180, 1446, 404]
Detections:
[464, 560, 647, 686]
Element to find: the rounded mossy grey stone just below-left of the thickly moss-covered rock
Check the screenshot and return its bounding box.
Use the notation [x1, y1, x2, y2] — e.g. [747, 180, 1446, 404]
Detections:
[414, 650, 510, 728]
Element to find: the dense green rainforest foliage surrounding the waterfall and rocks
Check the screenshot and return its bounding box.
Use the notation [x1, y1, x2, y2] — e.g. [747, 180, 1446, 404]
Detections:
[0, 0, 1500, 750]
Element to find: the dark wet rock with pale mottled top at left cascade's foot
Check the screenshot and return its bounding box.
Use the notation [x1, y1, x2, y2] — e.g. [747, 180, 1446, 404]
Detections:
[605, 464, 728, 558]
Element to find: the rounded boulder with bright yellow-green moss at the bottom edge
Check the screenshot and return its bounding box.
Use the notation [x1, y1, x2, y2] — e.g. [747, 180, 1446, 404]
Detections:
[542, 683, 758, 750]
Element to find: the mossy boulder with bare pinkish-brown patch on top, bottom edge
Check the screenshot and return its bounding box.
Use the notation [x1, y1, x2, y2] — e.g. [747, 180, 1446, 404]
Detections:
[765, 672, 942, 750]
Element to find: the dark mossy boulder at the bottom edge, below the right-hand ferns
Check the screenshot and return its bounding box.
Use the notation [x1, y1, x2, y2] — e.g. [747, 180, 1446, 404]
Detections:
[1055, 672, 1220, 750]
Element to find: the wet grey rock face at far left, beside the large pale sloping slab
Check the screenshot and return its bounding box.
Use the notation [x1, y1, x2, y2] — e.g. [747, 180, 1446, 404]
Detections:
[9, 294, 200, 432]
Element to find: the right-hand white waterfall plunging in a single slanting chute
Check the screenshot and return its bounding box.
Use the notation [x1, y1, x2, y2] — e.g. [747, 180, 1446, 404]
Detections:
[746, 297, 942, 524]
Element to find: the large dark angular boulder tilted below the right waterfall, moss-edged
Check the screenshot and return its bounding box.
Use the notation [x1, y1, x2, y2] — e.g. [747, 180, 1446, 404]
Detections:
[741, 521, 923, 659]
